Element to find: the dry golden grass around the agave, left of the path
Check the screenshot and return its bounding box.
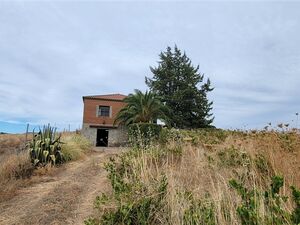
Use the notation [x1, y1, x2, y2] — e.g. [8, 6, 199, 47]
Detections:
[0, 133, 90, 202]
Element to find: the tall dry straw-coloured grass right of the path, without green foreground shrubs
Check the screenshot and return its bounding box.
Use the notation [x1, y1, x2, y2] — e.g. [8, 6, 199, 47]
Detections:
[93, 131, 300, 224]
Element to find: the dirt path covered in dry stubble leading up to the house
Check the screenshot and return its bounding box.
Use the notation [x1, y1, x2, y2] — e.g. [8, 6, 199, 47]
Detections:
[0, 149, 118, 225]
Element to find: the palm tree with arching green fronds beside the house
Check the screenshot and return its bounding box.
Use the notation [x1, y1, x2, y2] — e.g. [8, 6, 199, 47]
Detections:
[115, 89, 167, 126]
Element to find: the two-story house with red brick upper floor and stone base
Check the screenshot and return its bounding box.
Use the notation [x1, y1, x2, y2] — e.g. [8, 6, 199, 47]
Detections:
[82, 94, 127, 146]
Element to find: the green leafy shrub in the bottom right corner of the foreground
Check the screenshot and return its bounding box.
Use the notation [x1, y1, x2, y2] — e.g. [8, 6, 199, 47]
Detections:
[229, 176, 300, 225]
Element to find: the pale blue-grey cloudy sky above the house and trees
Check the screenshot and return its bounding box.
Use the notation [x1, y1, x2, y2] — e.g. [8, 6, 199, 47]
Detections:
[0, 1, 300, 133]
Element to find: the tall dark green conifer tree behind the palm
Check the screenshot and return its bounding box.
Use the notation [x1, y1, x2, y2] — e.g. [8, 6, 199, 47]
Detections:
[145, 45, 214, 128]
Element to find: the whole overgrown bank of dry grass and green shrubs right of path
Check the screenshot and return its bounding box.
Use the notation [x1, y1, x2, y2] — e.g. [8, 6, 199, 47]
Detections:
[85, 129, 300, 225]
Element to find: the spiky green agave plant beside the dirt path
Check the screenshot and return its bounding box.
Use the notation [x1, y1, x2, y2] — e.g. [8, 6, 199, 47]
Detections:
[29, 124, 64, 166]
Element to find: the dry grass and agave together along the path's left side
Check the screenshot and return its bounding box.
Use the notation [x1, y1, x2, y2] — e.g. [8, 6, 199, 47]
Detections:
[0, 126, 91, 201]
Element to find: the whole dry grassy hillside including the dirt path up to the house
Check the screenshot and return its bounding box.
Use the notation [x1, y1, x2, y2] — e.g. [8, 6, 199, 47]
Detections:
[0, 129, 300, 225]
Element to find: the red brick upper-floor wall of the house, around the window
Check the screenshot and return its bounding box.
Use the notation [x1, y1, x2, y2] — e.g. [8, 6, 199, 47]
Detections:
[83, 98, 125, 125]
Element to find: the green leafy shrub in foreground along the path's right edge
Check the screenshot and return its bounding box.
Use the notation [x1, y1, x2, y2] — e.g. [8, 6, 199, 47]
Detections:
[85, 153, 168, 225]
